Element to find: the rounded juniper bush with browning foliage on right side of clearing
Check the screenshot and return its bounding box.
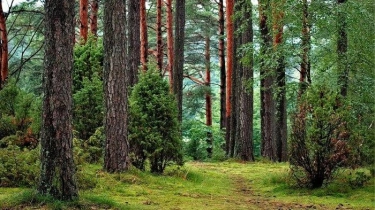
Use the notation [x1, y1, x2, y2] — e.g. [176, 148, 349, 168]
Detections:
[290, 87, 350, 188]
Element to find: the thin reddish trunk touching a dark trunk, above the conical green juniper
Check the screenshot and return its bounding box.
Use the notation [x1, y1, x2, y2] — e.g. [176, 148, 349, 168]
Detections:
[139, 0, 148, 71]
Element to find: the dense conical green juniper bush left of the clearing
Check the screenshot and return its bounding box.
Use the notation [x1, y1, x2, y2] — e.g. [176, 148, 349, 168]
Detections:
[129, 65, 182, 173]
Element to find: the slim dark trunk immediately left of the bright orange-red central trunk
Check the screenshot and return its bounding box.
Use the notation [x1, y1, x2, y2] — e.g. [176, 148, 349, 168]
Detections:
[219, 0, 226, 129]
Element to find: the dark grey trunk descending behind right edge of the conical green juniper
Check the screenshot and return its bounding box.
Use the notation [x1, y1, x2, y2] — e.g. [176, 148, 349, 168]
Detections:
[173, 0, 185, 122]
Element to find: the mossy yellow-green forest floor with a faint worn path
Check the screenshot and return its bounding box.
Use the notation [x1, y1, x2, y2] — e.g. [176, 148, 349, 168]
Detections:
[0, 161, 375, 210]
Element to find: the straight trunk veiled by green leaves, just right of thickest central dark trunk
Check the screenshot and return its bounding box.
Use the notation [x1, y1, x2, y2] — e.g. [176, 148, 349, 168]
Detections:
[258, 0, 276, 160]
